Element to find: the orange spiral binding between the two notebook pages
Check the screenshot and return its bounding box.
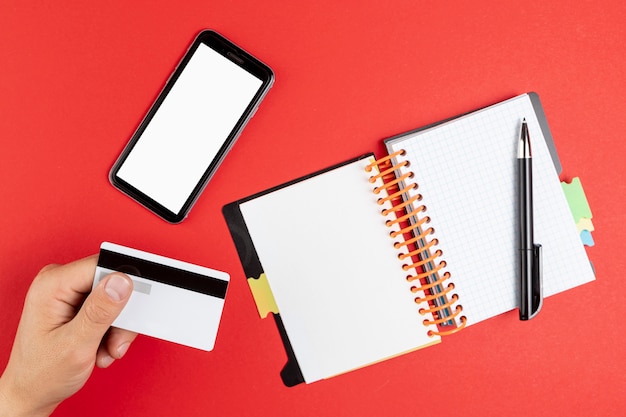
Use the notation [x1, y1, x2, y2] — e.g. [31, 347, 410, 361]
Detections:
[365, 150, 467, 336]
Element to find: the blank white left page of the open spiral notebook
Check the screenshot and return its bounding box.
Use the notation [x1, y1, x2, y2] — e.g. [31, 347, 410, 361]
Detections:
[240, 158, 439, 383]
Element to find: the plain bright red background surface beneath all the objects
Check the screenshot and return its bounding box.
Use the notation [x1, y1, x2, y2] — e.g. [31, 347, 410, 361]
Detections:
[0, 0, 626, 416]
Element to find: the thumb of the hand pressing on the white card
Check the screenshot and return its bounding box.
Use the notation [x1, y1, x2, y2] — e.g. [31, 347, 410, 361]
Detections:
[74, 272, 133, 346]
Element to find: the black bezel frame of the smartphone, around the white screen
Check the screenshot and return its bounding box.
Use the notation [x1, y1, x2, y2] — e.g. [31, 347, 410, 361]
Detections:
[109, 29, 274, 223]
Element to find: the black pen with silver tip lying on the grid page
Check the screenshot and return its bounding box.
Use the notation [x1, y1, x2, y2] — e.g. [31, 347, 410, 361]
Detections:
[517, 119, 543, 320]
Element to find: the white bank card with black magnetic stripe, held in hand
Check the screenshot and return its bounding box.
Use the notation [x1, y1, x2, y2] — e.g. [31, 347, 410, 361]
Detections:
[93, 242, 230, 351]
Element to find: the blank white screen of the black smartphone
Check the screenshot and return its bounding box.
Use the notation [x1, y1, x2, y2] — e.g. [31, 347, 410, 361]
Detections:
[117, 44, 263, 213]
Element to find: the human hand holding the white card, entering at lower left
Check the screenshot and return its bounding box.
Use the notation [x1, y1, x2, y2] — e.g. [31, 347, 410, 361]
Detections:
[0, 255, 136, 417]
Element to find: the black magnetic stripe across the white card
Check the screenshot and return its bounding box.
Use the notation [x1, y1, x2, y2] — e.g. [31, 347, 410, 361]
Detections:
[98, 249, 228, 299]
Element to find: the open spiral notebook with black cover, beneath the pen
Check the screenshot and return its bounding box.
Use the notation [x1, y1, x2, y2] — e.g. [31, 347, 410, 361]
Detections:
[224, 94, 594, 385]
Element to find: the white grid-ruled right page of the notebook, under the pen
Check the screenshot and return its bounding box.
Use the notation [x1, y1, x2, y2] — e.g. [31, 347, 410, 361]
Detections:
[387, 94, 594, 324]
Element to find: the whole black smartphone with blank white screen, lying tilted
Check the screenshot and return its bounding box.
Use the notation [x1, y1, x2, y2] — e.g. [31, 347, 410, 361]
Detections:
[109, 30, 274, 223]
